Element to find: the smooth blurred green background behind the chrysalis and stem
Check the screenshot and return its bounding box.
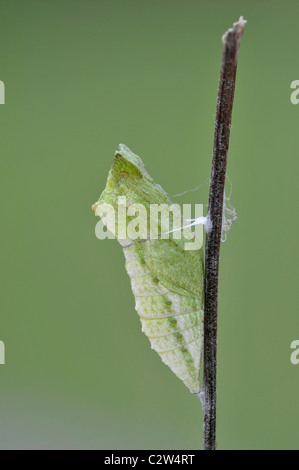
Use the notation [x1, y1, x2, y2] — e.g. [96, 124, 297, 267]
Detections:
[0, 0, 299, 449]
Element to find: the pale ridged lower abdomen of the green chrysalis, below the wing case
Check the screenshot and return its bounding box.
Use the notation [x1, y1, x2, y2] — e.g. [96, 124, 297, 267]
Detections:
[123, 240, 203, 393]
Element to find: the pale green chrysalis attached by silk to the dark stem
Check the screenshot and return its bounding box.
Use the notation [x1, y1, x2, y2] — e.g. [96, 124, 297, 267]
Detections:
[93, 144, 204, 393]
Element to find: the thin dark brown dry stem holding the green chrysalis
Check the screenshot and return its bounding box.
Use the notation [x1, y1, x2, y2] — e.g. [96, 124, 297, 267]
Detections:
[202, 17, 246, 450]
